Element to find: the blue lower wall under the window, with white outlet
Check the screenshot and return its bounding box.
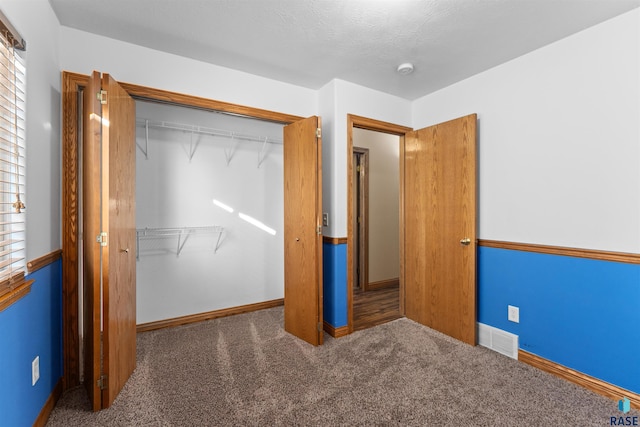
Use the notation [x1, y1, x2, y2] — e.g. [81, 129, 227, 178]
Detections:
[0, 260, 62, 427]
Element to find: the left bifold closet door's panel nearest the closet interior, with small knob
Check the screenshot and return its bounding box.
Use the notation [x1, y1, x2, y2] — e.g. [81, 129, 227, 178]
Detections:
[102, 74, 136, 408]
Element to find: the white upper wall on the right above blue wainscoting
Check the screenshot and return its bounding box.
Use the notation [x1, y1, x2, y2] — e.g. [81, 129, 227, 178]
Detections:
[413, 9, 640, 253]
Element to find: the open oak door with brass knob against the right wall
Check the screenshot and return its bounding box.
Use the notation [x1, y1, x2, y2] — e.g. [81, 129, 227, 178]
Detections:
[404, 114, 477, 345]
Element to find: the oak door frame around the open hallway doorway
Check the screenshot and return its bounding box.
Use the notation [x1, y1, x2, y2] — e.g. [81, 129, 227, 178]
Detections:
[347, 114, 413, 334]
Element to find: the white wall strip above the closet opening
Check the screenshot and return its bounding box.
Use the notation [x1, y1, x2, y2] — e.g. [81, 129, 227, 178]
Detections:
[60, 27, 317, 117]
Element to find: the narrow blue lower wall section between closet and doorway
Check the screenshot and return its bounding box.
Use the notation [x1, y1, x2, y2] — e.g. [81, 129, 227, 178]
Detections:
[322, 242, 347, 328]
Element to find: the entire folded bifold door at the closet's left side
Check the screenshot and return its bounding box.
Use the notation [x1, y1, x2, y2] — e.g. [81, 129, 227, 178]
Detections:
[82, 71, 136, 411]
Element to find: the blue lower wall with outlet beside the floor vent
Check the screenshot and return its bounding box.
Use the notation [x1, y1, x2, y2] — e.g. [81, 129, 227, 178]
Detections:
[478, 247, 640, 393]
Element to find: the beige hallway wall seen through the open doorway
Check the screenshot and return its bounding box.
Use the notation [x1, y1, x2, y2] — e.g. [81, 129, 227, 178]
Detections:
[353, 128, 400, 283]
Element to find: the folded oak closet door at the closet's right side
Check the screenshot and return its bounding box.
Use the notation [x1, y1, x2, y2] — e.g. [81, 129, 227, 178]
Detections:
[283, 116, 324, 345]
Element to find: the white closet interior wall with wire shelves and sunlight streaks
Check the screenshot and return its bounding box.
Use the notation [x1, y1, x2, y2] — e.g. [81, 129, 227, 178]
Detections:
[136, 100, 284, 324]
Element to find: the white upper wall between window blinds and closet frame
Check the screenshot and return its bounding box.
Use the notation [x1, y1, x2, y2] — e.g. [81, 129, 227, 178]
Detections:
[0, 0, 61, 260]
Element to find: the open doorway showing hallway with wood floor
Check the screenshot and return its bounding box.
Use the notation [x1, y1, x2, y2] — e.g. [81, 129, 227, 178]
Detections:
[350, 127, 401, 330]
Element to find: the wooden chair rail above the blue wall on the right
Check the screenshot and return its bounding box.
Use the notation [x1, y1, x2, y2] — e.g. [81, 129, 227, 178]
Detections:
[478, 239, 640, 264]
